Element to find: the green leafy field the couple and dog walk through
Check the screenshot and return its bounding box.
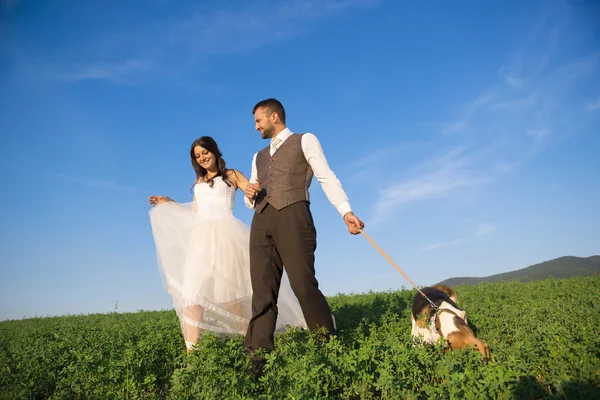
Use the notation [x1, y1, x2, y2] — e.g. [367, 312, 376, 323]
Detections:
[0, 276, 600, 399]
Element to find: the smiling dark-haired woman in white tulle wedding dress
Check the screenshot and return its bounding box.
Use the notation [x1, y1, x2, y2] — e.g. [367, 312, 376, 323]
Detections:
[148, 136, 306, 352]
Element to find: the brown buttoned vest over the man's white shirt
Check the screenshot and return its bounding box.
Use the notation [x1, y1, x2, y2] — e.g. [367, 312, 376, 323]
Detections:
[255, 133, 313, 212]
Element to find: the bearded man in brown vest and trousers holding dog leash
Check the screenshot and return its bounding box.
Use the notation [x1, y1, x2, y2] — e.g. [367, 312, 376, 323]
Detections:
[244, 99, 364, 353]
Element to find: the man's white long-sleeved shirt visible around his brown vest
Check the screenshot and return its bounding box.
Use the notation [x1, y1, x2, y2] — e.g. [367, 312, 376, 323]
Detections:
[244, 128, 352, 216]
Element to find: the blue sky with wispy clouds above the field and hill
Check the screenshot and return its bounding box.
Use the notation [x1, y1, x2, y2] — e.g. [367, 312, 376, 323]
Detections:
[0, 0, 600, 319]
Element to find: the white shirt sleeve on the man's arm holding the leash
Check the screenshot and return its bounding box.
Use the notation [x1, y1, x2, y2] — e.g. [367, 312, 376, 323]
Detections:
[302, 133, 352, 217]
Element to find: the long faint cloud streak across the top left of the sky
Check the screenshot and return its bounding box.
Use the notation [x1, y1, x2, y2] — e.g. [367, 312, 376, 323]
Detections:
[39, 0, 381, 83]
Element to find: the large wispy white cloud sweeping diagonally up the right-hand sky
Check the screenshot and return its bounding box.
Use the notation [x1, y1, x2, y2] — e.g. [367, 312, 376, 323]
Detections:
[373, 3, 600, 220]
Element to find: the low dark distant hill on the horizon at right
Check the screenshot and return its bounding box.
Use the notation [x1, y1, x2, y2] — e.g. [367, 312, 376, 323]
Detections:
[439, 256, 600, 286]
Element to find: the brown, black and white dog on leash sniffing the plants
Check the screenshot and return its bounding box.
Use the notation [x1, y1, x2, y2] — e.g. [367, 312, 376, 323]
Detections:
[411, 285, 490, 361]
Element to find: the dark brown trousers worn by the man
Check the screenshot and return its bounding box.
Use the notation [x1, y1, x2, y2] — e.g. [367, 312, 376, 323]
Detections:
[244, 202, 334, 352]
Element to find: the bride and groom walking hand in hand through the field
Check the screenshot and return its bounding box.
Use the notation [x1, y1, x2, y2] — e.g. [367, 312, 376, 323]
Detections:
[149, 99, 364, 360]
